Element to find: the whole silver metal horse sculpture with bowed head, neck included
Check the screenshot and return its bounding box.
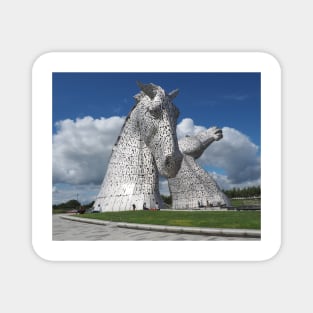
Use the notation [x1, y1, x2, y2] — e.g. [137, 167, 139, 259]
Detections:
[94, 82, 183, 211]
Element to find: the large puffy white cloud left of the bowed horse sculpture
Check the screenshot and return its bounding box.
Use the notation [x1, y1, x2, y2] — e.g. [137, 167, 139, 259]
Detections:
[53, 116, 125, 184]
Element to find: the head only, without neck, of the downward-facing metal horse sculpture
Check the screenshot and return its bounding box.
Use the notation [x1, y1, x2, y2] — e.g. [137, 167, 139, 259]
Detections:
[133, 82, 183, 178]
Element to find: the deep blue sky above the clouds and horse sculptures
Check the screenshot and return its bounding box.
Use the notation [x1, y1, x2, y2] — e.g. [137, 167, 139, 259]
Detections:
[53, 73, 261, 145]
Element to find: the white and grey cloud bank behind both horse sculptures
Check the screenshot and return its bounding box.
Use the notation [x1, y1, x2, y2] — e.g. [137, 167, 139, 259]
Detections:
[53, 116, 260, 203]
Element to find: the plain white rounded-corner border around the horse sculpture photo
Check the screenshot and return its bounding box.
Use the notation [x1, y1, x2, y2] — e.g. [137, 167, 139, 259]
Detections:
[32, 52, 281, 261]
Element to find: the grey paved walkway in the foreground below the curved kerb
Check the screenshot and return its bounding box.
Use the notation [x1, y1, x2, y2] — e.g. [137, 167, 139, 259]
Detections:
[52, 215, 260, 241]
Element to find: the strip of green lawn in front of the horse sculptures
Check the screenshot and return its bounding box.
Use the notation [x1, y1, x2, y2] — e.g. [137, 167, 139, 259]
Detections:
[78, 211, 261, 229]
